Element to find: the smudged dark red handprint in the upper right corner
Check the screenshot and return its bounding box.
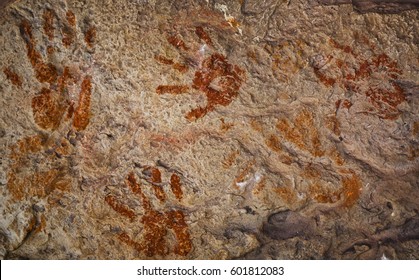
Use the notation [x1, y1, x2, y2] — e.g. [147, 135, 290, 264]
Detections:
[311, 36, 406, 120]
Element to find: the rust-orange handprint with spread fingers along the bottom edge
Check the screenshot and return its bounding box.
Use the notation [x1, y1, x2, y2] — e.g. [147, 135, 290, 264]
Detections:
[105, 167, 192, 257]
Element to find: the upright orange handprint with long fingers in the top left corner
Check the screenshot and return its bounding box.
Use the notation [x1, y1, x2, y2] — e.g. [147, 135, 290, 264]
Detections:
[20, 9, 96, 131]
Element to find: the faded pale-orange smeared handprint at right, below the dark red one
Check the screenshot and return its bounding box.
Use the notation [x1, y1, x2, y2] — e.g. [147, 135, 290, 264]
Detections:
[248, 107, 363, 208]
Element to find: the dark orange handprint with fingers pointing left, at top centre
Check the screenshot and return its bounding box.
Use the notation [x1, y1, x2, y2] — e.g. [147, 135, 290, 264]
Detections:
[156, 26, 245, 121]
